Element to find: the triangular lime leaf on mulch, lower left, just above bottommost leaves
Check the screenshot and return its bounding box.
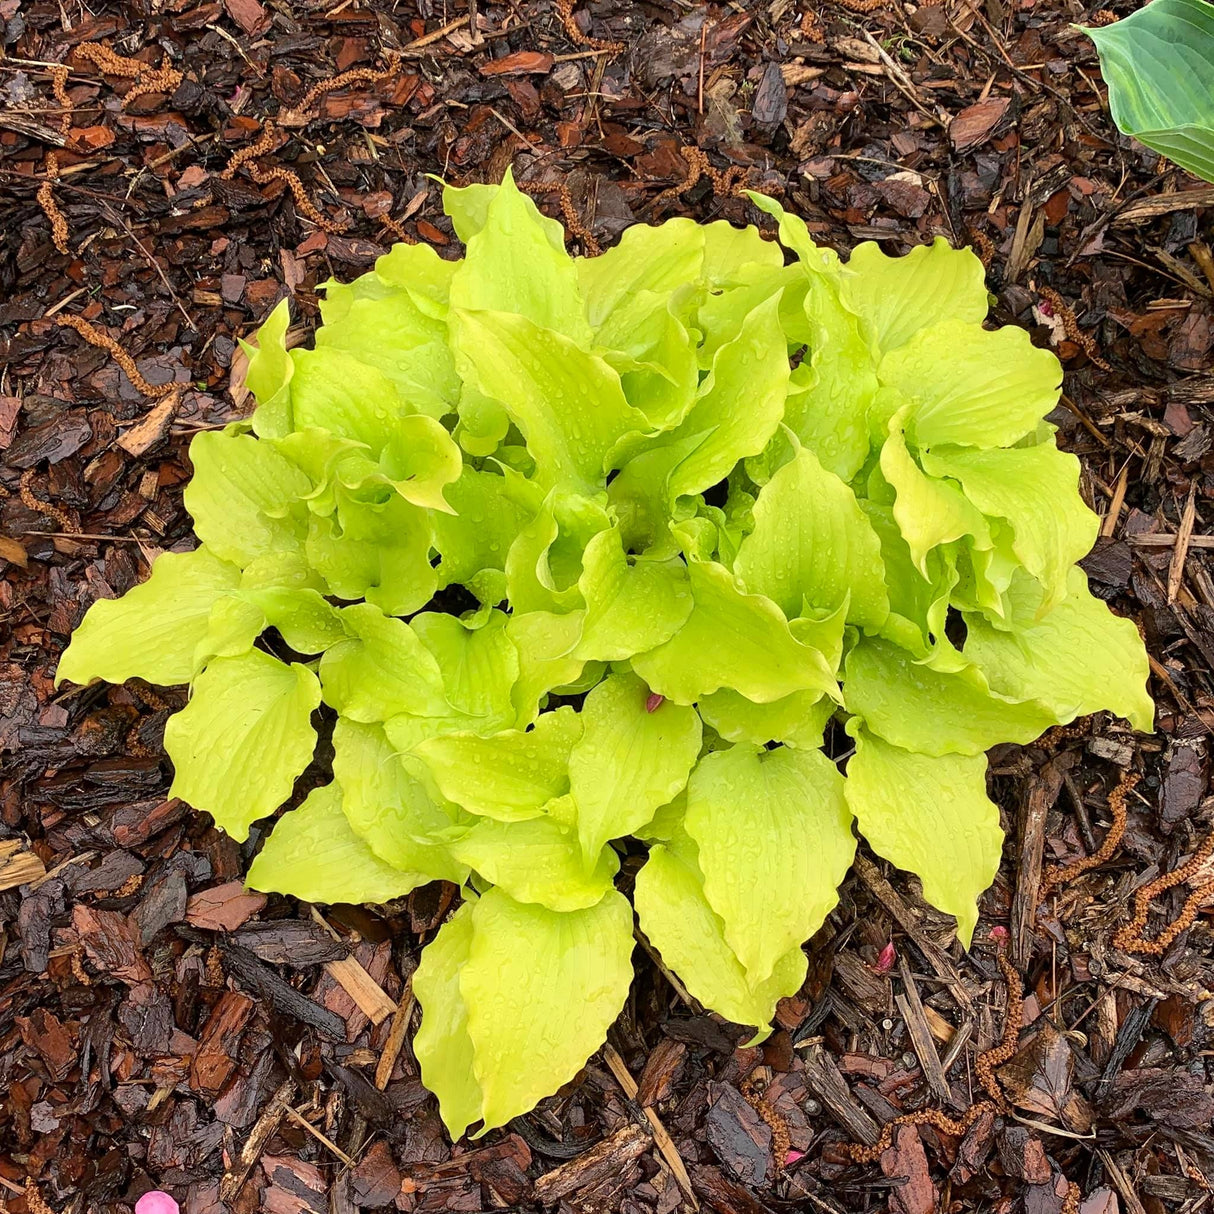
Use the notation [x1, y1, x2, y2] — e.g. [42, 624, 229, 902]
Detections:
[245, 784, 430, 903]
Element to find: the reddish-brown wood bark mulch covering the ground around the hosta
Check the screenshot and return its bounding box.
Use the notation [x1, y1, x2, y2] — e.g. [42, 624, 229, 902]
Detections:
[0, 0, 1214, 1214]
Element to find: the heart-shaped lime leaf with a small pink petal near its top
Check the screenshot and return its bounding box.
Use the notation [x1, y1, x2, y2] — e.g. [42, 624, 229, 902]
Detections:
[569, 674, 702, 864]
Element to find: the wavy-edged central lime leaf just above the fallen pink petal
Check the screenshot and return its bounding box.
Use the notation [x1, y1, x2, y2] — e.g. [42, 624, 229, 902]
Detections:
[632, 561, 839, 704]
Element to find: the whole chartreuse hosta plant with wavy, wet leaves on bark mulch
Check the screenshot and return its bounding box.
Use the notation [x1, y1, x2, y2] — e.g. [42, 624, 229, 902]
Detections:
[58, 177, 1152, 1136]
